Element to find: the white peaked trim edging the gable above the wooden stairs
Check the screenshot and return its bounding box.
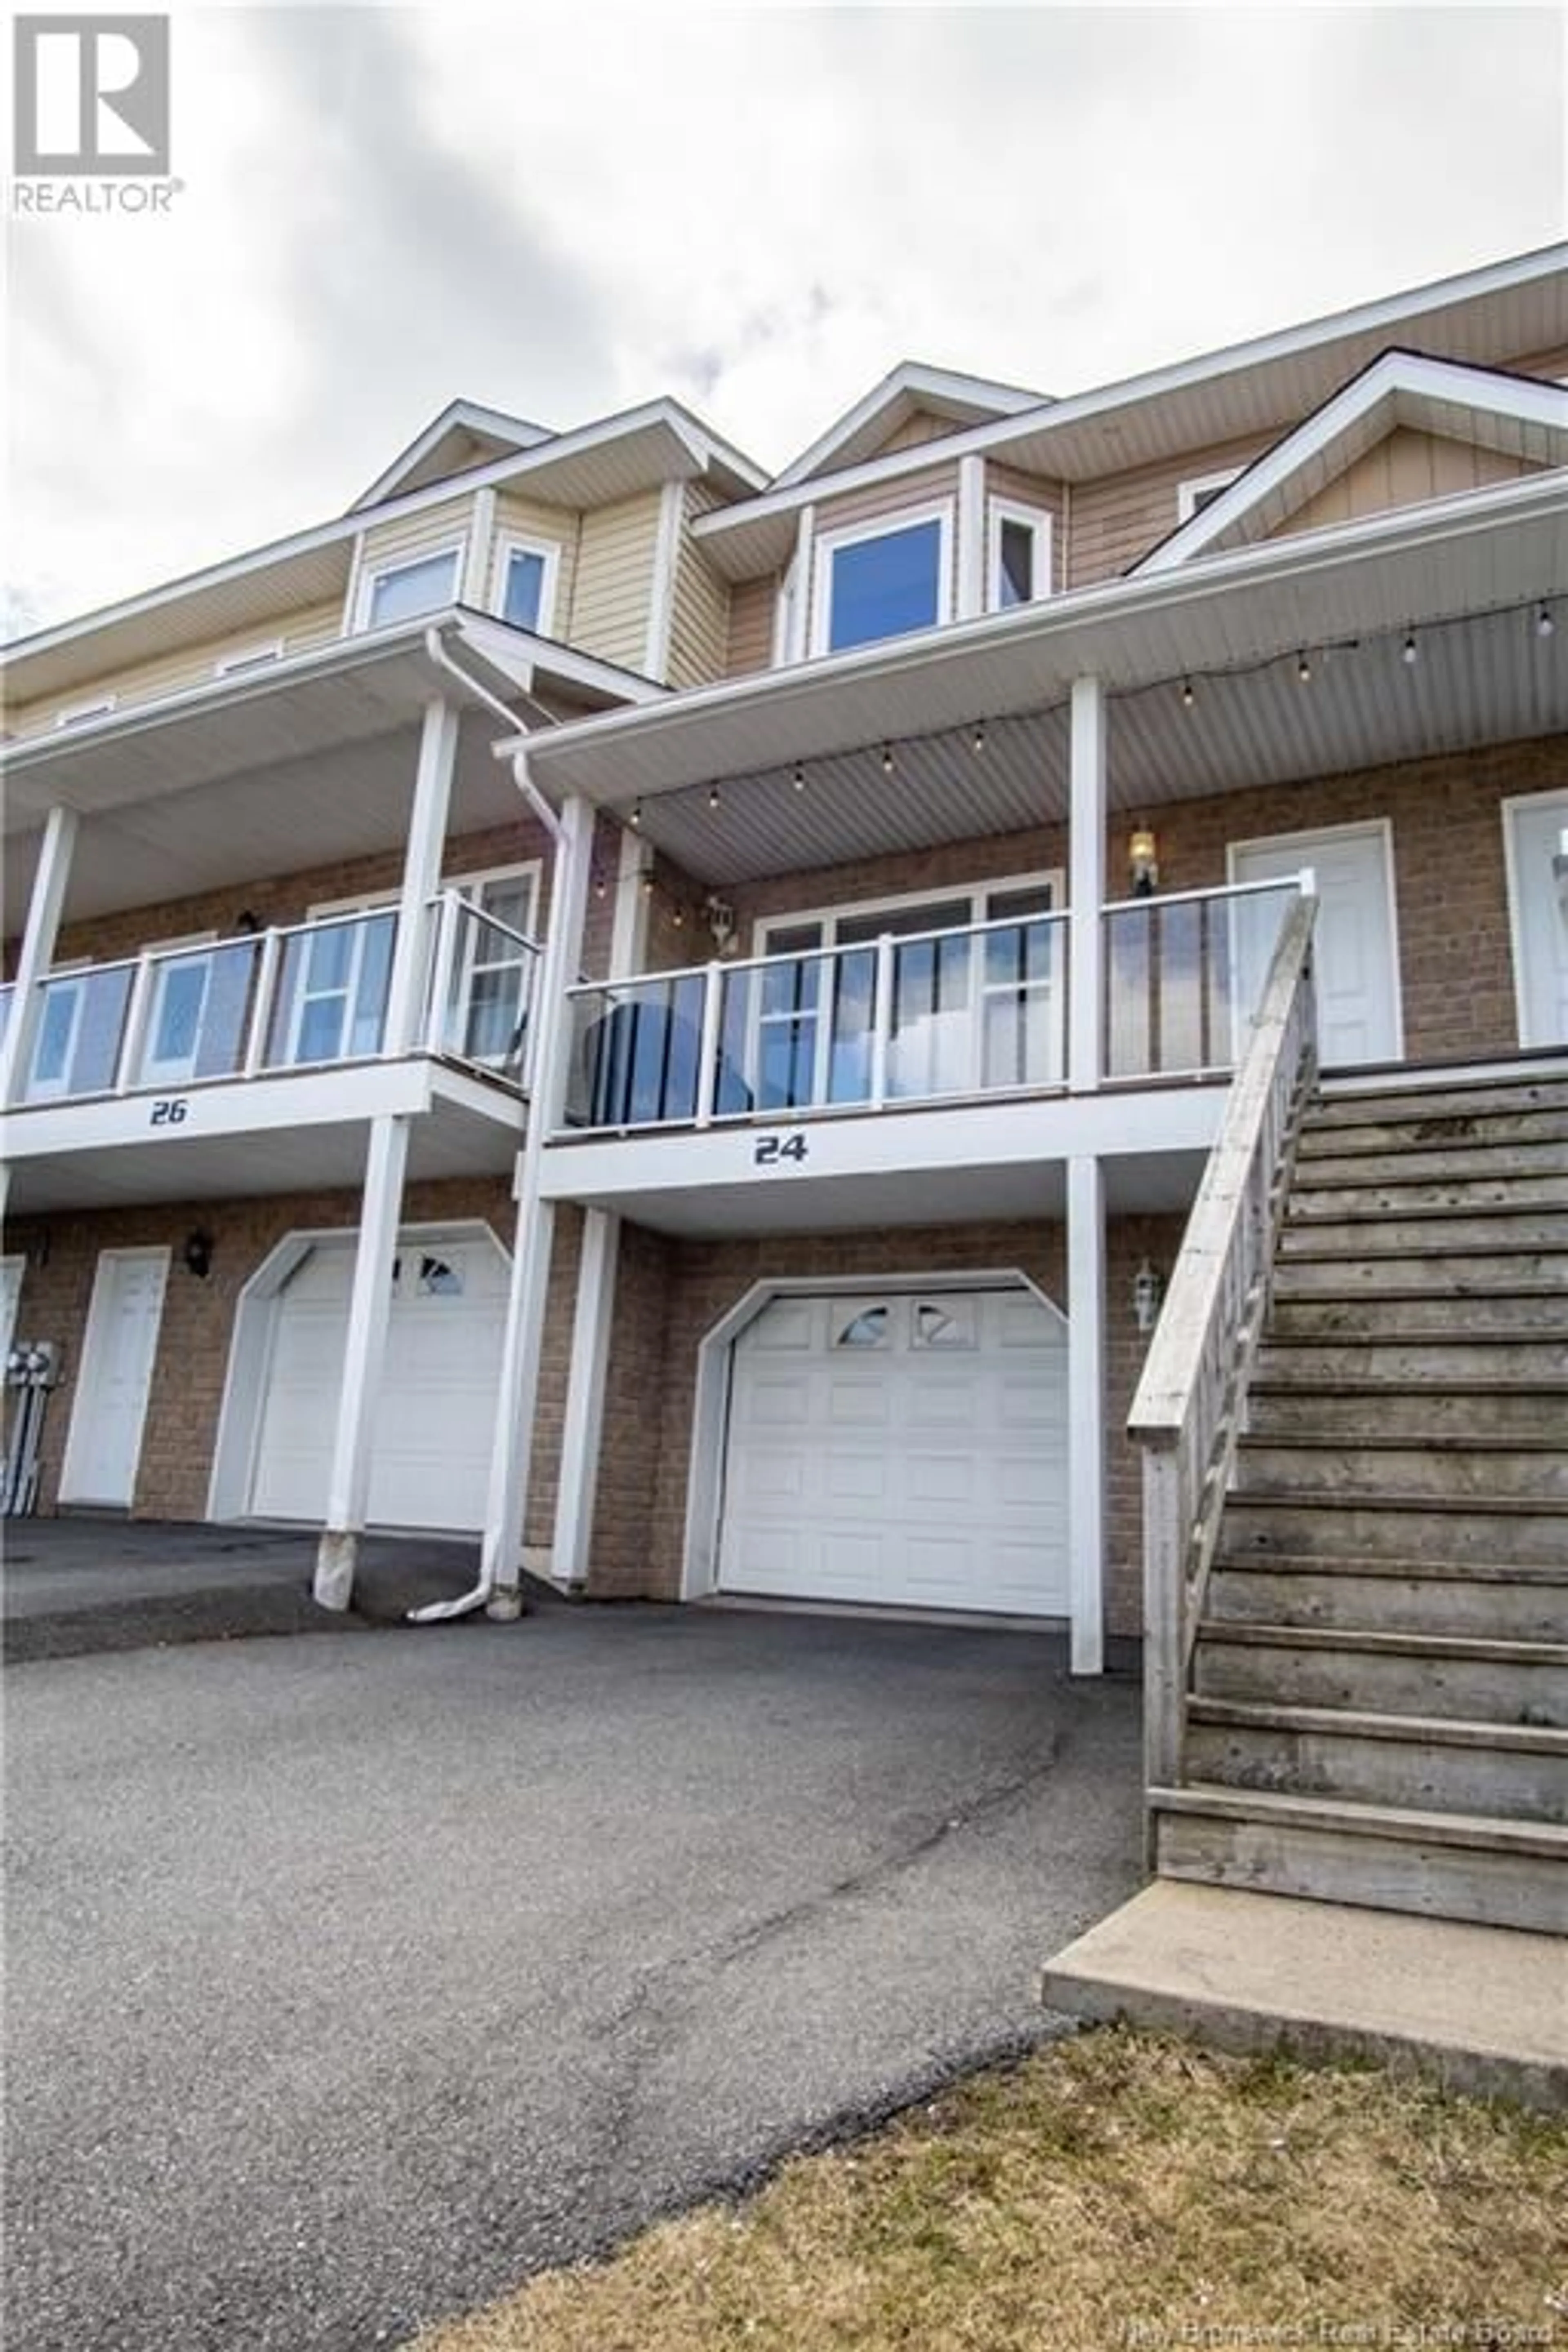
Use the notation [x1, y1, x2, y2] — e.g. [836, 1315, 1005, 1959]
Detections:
[1133, 350, 1568, 576]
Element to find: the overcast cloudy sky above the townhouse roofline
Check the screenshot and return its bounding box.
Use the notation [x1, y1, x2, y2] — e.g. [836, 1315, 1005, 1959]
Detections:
[5, 0, 1568, 630]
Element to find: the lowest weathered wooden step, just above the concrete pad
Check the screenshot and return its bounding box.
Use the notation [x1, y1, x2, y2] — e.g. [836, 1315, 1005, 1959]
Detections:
[1149, 1785, 1568, 1936]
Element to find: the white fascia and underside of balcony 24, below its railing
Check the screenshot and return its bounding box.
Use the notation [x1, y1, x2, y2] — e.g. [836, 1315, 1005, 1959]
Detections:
[543, 1084, 1225, 1237]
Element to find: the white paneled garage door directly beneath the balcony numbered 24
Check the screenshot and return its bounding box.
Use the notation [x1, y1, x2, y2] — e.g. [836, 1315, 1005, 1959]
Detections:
[719, 1289, 1067, 1616]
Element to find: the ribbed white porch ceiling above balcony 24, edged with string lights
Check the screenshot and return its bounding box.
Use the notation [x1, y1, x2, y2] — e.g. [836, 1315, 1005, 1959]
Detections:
[620, 609, 1568, 889]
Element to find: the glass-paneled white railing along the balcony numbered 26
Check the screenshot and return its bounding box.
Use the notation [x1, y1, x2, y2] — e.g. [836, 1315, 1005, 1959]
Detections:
[7, 891, 538, 1103]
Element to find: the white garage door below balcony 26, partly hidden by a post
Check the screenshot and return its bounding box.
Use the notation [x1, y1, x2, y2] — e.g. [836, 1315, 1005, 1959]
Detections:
[252, 1232, 508, 1529]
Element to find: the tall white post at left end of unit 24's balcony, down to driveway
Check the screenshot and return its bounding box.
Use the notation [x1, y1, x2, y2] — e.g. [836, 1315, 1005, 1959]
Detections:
[479, 795, 592, 1618]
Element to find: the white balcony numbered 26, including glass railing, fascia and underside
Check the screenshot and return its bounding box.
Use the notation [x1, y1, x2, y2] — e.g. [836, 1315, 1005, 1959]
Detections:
[7, 891, 541, 1209]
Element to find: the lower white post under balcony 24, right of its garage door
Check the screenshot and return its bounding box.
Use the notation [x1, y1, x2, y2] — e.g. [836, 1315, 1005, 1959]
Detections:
[1067, 1160, 1105, 1675]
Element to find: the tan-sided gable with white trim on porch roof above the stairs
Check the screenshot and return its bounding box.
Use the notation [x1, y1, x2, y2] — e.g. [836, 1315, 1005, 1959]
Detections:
[1133, 350, 1568, 572]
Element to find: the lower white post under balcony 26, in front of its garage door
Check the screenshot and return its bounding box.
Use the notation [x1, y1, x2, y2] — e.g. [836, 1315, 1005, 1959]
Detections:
[315, 1117, 409, 1609]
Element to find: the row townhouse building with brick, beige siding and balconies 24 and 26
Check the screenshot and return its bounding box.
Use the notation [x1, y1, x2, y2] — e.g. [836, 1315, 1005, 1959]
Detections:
[0, 249, 1568, 1712]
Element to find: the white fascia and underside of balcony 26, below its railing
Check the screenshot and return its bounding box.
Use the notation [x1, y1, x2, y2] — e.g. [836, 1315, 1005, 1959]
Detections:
[7, 1056, 524, 1216]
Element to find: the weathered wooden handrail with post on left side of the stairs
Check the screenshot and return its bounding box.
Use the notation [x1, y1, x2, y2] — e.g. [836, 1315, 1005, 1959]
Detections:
[1126, 898, 1316, 1788]
